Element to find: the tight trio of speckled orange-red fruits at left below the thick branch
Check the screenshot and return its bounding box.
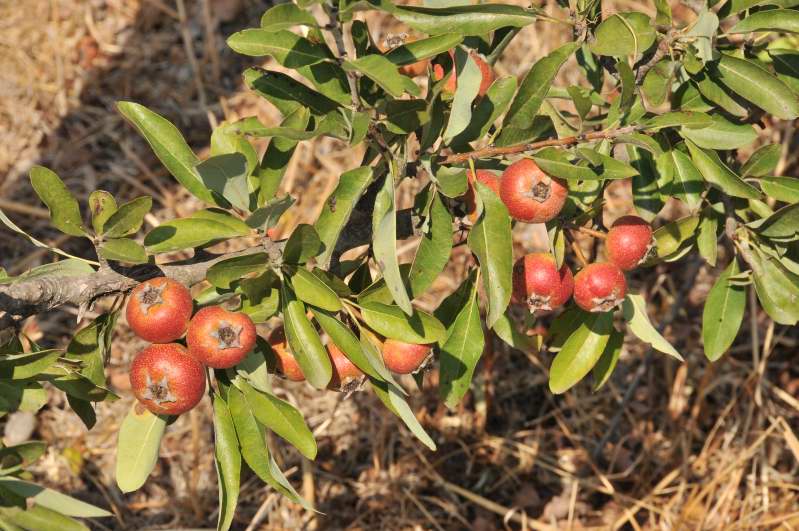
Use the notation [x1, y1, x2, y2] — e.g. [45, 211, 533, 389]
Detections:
[126, 277, 256, 415]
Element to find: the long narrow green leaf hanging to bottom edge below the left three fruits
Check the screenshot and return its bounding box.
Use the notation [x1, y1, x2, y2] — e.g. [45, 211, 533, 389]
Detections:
[213, 393, 241, 531]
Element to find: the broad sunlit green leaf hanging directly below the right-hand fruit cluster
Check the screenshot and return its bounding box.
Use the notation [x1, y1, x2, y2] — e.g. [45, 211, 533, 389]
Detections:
[549, 312, 613, 394]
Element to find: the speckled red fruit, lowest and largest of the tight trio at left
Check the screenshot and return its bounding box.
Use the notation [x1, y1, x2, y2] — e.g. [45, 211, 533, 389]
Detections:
[130, 343, 205, 415]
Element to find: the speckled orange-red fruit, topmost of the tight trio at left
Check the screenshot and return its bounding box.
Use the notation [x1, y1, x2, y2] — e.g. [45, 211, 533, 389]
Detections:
[125, 277, 192, 343]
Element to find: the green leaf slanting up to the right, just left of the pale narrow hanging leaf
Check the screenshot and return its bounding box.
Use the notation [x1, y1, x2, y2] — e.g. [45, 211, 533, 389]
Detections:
[314, 166, 372, 265]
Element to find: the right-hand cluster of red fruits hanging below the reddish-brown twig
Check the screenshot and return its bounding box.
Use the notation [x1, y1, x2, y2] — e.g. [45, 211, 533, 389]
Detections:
[465, 159, 655, 312]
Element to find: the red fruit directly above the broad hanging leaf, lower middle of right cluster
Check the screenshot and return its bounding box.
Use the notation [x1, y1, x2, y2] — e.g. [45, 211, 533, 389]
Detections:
[574, 262, 627, 312]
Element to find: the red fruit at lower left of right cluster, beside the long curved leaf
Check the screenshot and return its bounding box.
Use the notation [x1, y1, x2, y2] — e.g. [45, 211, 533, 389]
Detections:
[513, 253, 574, 312]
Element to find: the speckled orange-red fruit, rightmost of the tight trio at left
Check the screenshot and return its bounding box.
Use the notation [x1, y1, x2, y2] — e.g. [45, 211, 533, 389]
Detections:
[186, 306, 255, 369]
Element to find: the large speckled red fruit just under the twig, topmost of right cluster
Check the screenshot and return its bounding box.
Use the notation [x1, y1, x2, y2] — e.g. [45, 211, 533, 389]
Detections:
[499, 159, 569, 223]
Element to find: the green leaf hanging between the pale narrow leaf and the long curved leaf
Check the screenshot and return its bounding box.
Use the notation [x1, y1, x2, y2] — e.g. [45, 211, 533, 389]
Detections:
[408, 194, 452, 296]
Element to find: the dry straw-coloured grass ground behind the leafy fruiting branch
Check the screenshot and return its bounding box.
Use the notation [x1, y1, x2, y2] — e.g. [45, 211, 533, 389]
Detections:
[0, 0, 799, 531]
